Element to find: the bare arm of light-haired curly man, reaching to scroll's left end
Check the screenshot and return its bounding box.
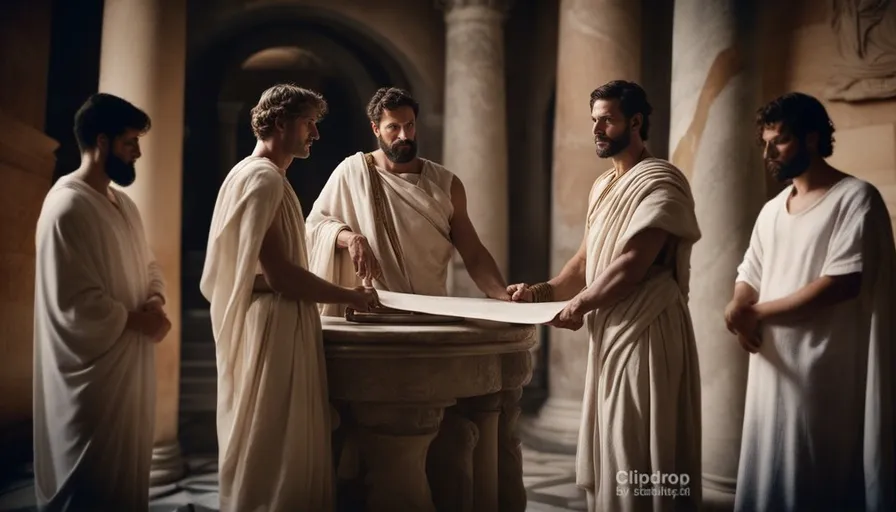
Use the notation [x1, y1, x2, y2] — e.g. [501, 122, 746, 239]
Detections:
[258, 212, 360, 304]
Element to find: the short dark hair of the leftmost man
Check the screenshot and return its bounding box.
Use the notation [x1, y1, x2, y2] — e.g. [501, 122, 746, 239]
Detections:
[74, 92, 152, 151]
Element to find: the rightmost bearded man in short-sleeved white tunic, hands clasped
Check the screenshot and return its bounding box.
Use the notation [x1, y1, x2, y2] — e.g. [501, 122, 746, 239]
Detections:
[725, 93, 896, 511]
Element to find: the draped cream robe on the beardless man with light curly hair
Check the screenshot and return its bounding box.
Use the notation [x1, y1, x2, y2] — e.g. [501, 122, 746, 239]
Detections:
[200, 157, 333, 512]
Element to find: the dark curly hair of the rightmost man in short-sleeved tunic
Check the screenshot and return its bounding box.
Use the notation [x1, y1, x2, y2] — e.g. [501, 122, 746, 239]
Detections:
[756, 92, 835, 158]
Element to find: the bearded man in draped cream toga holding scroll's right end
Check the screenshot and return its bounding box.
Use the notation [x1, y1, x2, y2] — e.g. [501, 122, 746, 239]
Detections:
[508, 81, 701, 512]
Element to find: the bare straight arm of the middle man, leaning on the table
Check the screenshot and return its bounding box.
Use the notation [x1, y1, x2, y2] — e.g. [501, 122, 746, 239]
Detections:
[451, 177, 509, 299]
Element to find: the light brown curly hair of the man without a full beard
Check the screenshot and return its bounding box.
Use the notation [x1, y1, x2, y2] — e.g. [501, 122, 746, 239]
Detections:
[251, 84, 327, 140]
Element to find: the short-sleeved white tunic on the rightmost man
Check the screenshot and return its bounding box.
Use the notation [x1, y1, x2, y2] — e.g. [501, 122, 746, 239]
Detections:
[736, 177, 896, 512]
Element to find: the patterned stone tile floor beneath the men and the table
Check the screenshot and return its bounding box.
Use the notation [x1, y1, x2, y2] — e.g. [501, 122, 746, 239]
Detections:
[0, 442, 586, 512]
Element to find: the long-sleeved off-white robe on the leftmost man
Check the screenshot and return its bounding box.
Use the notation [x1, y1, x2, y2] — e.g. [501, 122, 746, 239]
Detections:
[34, 176, 164, 511]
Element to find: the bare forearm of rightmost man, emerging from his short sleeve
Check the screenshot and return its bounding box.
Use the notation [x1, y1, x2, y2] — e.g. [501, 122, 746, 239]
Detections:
[755, 274, 861, 322]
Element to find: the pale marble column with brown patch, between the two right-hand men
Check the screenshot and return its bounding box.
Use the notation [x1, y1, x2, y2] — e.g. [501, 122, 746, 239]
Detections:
[669, 0, 765, 510]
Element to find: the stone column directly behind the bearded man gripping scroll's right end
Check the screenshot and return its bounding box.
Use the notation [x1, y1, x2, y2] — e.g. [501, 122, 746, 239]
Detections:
[523, 0, 641, 452]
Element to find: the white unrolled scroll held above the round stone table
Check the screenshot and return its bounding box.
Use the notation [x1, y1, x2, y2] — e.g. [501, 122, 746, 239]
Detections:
[377, 290, 567, 325]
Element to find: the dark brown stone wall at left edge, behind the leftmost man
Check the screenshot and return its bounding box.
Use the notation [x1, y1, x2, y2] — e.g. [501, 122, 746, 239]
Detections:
[0, 0, 57, 471]
